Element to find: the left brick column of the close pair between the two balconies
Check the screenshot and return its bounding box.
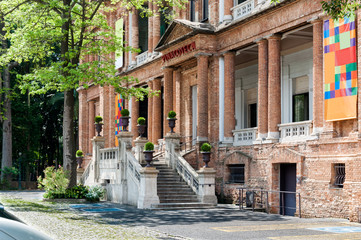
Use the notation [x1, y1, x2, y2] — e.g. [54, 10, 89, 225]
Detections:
[256, 39, 268, 143]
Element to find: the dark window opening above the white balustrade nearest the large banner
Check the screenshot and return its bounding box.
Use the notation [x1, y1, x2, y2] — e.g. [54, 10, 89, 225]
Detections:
[292, 93, 309, 122]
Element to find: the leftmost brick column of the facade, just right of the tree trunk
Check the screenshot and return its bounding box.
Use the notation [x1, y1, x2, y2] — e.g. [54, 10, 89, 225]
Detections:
[78, 87, 91, 153]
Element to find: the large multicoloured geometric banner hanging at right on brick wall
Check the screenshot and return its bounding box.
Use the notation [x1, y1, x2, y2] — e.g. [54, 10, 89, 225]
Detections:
[323, 15, 357, 121]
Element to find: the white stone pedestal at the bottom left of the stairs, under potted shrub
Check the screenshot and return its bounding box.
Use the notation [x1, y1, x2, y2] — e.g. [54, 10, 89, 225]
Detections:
[138, 167, 159, 209]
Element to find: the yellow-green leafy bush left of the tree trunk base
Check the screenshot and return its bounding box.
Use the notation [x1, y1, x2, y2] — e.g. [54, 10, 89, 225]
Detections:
[38, 167, 69, 198]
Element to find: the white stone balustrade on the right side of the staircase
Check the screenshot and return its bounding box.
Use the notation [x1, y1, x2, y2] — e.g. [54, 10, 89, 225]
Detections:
[169, 153, 199, 194]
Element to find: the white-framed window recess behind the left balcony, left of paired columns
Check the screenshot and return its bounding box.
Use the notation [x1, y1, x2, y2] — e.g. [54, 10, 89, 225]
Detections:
[235, 65, 258, 129]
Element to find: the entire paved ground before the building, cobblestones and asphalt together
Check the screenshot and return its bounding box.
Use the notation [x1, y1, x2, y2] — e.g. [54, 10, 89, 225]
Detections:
[0, 192, 361, 240]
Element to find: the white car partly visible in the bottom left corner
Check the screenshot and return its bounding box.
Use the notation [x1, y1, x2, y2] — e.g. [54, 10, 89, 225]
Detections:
[0, 217, 51, 240]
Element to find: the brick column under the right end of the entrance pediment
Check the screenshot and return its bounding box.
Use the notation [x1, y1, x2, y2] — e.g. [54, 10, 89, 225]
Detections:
[197, 53, 209, 142]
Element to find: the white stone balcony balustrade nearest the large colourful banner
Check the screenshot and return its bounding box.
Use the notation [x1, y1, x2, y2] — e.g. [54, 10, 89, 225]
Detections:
[278, 120, 312, 142]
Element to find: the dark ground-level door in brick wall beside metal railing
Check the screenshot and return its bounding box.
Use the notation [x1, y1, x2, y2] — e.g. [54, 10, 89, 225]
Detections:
[280, 163, 296, 216]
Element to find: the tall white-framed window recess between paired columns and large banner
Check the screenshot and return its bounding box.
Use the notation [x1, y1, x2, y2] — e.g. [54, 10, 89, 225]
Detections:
[281, 49, 313, 123]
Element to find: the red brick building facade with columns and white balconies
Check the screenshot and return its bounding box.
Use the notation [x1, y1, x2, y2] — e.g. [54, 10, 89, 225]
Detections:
[79, 0, 361, 220]
